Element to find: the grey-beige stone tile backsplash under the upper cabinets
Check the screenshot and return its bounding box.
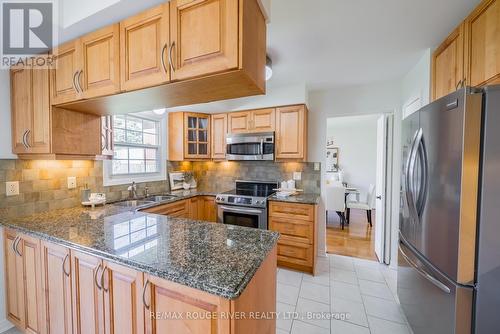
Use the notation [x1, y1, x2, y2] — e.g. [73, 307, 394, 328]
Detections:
[0, 160, 321, 217]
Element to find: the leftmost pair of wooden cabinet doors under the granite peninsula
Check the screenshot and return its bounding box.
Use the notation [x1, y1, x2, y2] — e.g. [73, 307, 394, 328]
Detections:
[4, 230, 45, 334]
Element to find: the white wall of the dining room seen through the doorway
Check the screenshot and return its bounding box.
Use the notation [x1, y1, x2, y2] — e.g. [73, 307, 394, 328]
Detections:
[326, 115, 379, 201]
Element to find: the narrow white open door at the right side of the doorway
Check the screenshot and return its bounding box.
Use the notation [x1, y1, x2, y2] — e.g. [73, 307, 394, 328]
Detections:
[374, 115, 387, 263]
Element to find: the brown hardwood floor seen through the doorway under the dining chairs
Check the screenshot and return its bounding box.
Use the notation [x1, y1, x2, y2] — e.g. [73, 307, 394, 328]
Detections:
[326, 209, 377, 260]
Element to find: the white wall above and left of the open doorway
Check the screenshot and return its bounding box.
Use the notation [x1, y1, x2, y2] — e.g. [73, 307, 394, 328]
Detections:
[308, 79, 401, 255]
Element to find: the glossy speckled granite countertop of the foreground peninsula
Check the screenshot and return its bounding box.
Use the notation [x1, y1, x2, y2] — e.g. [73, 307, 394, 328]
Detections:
[0, 190, 279, 299]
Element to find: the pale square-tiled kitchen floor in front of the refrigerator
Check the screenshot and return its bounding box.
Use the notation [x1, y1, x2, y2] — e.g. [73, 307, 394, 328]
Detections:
[0, 255, 411, 334]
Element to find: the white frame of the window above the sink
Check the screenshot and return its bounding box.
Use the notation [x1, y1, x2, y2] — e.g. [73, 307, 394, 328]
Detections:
[103, 116, 167, 187]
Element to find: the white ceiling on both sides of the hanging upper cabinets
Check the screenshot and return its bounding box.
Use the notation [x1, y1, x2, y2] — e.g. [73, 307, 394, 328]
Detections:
[60, 0, 479, 90]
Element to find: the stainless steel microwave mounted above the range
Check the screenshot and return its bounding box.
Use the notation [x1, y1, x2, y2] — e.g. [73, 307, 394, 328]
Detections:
[226, 132, 275, 161]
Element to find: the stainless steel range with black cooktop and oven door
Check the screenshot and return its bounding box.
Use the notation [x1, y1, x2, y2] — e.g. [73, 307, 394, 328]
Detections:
[215, 181, 278, 230]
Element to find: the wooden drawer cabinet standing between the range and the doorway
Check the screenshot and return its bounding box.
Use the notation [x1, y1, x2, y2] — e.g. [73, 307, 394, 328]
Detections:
[269, 202, 317, 274]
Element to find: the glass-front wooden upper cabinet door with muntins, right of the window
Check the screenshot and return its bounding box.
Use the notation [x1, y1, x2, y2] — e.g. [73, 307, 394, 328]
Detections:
[184, 113, 210, 159]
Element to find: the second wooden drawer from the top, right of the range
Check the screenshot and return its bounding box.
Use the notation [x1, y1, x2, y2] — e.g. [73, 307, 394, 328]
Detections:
[269, 217, 314, 244]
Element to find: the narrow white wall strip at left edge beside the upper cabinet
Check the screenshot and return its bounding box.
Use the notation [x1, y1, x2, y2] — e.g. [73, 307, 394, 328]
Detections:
[0, 70, 16, 159]
